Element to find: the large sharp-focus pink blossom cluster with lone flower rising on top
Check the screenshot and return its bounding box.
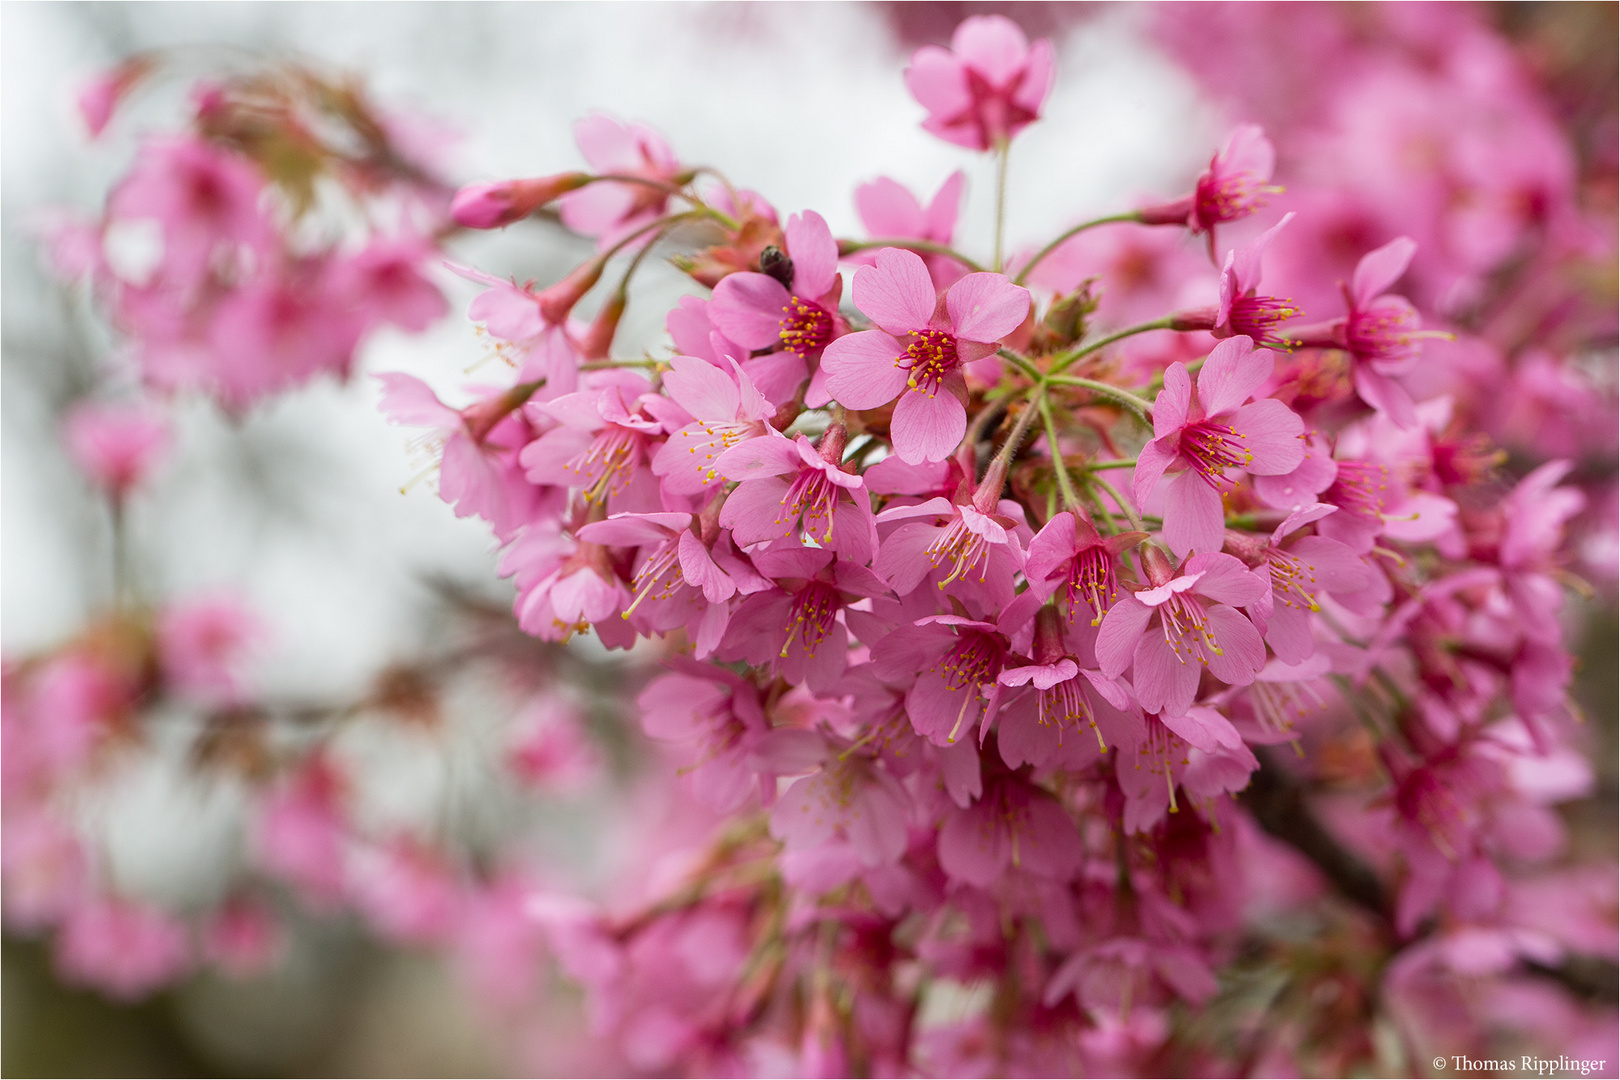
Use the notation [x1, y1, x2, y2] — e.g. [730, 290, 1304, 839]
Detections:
[364, 16, 1614, 1075]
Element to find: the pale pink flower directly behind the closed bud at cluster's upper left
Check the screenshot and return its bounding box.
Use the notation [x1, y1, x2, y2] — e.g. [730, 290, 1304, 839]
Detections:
[557, 113, 682, 251]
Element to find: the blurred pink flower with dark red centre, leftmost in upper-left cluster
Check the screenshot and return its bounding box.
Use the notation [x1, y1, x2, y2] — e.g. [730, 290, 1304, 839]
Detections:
[107, 138, 274, 290]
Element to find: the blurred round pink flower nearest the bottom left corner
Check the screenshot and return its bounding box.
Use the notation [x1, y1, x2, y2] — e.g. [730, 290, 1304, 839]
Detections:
[57, 897, 191, 1001]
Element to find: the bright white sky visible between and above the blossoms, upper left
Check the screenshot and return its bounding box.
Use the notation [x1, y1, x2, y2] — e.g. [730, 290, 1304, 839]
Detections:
[0, 3, 1220, 696]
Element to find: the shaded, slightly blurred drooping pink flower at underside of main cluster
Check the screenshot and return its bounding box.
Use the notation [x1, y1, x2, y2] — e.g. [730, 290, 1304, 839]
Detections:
[940, 776, 1084, 889]
